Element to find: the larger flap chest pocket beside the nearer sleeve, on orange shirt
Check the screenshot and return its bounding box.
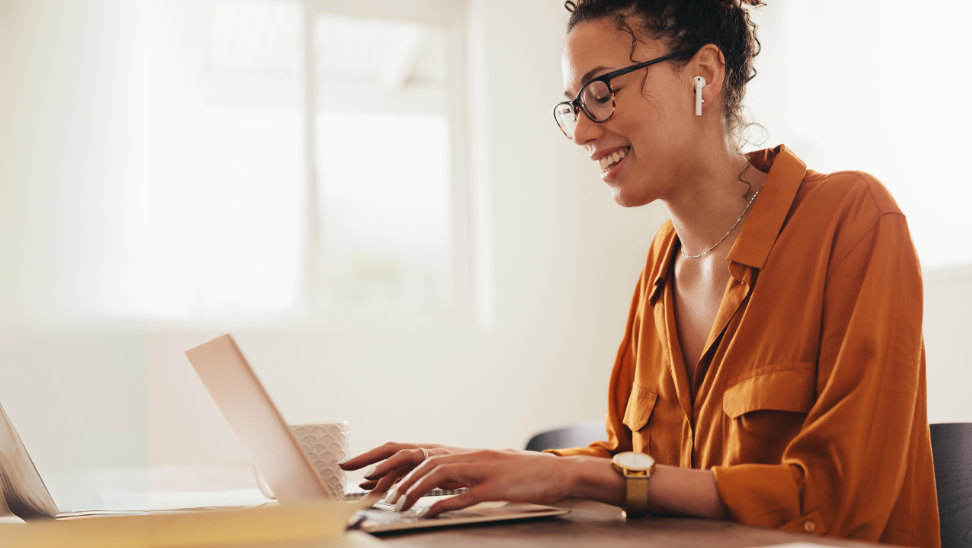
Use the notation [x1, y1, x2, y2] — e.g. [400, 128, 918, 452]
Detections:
[722, 362, 817, 464]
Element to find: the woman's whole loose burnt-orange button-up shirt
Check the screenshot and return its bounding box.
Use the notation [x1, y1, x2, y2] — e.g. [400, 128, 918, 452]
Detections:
[555, 146, 940, 547]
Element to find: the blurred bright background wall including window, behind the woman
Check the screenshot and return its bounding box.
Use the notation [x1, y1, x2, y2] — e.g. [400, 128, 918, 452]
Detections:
[0, 0, 972, 507]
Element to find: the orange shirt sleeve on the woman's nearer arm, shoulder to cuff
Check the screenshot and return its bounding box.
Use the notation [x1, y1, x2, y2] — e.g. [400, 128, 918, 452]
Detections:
[712, 212, 926, 541]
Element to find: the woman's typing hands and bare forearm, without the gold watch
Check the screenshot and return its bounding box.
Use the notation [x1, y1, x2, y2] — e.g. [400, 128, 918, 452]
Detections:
[341, 443, 730, 519]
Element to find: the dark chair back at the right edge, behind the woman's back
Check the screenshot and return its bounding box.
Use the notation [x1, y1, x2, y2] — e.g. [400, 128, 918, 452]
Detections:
[931, 423, 972, 548]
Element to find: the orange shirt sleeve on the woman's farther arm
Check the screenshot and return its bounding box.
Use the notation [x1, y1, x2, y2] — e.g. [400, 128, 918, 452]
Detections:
[545, 268, 650, 458]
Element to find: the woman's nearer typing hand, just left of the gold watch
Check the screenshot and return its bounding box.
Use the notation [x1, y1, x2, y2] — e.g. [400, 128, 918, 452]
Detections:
[386, 450, 573, 517]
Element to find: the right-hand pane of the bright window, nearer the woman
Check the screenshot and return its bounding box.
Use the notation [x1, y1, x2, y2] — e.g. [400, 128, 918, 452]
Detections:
[314, 14, 453, 309]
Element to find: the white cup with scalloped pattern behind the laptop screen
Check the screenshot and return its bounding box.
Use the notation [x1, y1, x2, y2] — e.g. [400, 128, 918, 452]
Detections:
[253, 421, 351, 500]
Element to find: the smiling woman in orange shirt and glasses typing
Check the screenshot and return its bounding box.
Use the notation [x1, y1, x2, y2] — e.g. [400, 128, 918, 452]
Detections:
[343, 0, 939, 546]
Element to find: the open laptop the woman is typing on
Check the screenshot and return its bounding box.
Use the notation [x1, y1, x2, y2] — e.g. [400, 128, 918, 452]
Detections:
[186, 335, 569, 533]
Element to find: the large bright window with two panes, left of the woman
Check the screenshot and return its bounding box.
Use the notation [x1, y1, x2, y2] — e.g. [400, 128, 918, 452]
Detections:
[151, 0, 465, 323]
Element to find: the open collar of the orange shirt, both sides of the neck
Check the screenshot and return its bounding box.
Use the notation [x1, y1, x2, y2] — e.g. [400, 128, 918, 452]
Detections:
[648, 145, 807, 306]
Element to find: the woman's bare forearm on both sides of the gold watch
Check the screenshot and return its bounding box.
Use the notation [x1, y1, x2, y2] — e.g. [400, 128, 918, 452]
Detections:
[561, 457, 729, 519]
